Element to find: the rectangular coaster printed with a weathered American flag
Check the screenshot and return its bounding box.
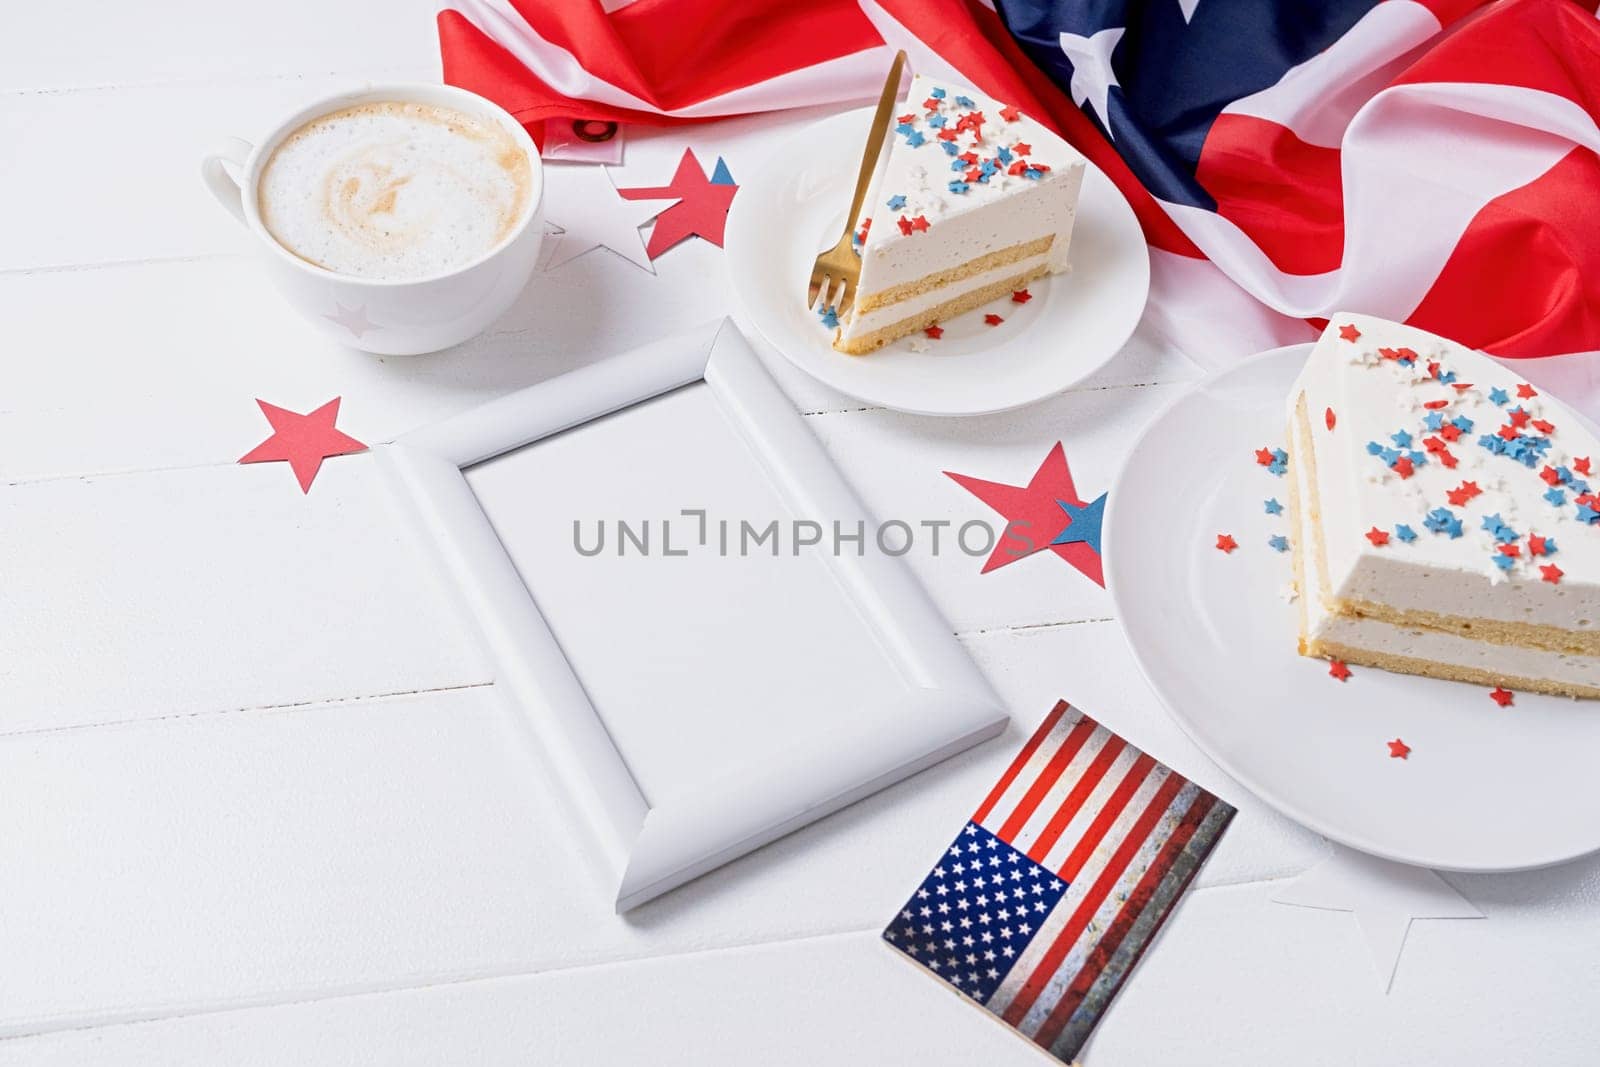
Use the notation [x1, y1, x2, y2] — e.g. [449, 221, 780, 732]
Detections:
[883, 702, 1234, 1062]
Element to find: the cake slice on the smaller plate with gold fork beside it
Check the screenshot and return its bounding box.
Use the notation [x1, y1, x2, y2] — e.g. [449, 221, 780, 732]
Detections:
[834, 75, 1085, 355]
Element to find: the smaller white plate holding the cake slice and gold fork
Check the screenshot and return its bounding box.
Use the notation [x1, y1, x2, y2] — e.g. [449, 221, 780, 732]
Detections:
[725, 107, 1150, 414]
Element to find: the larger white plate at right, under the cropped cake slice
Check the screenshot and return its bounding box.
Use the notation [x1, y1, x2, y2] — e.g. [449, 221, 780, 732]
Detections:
[1104, 346, 1600, 870]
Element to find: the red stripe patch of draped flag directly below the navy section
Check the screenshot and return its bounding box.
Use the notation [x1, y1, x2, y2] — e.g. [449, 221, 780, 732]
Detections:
[1195, 112, 1344, 274]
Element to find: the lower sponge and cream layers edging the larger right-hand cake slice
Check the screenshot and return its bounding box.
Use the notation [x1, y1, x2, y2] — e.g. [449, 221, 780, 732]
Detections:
[1290, 425, 1600, 697]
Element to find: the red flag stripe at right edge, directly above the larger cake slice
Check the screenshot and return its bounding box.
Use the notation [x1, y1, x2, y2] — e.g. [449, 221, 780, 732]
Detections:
[1406, 149, 1600, 357]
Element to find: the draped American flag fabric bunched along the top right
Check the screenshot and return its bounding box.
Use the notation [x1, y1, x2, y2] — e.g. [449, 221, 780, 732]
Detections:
[438, 0, 1600, 369]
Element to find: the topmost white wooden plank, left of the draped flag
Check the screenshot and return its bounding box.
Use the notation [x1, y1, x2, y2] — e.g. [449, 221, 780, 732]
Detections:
[0, 0, 438, 91]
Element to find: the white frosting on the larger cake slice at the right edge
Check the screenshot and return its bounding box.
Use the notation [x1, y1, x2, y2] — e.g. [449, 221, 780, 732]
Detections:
[1288, 314, 1600, 633]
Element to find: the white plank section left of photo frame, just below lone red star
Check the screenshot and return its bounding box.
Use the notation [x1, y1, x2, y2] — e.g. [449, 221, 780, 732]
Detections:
[0, 451, 490, 733]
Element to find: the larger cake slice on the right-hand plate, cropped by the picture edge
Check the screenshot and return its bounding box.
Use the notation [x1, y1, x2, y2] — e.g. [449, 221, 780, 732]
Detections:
[1288, 315, 1600, 697]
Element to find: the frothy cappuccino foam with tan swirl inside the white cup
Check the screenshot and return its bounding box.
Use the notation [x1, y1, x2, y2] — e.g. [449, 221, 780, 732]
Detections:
[256, 101, 533, 280]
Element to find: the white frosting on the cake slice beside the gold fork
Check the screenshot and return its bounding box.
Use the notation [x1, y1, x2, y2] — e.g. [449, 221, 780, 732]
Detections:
[845, 75, 1085, 336]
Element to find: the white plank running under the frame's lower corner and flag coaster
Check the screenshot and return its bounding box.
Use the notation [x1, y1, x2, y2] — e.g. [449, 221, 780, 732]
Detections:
[0, 624, 1322, 1035]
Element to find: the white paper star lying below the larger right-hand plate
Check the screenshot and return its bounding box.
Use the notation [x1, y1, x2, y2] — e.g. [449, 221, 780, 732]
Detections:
[1274, 845, 1483, 993]
